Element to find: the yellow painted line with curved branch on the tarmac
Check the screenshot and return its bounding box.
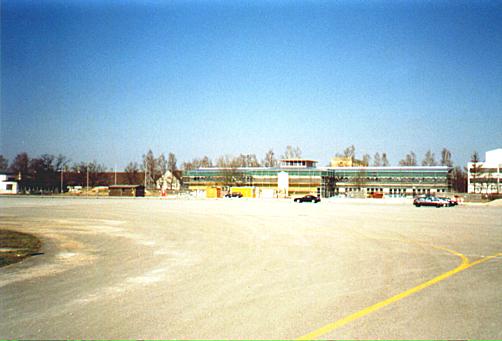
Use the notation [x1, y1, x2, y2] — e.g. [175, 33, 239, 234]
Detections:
[297, 246, 502, 340]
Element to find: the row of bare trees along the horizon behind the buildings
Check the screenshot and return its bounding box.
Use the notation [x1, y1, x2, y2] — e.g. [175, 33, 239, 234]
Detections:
[0, 145, 470, 192]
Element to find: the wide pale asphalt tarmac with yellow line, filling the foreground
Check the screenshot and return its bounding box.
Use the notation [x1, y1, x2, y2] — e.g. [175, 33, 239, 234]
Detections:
[0, 197, 502, 339]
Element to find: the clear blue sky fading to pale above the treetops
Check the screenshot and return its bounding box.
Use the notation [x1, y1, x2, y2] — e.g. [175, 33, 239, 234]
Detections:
[0, 0, 502, 168]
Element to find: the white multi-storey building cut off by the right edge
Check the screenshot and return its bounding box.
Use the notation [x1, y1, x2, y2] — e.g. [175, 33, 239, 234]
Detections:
[467, 148, 502, 194]
